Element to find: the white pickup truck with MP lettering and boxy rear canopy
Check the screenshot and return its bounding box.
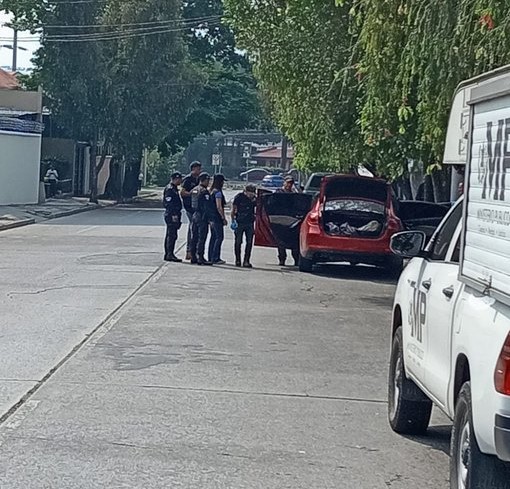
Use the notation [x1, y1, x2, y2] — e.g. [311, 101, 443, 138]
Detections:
[388, 67, 510, 489]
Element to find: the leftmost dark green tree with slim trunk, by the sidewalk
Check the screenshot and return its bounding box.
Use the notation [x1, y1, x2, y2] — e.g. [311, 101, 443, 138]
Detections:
[35, 0, 108, 201]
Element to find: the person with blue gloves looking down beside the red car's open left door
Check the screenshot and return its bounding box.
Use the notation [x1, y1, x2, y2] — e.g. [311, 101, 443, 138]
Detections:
[231, 185, 257, 268]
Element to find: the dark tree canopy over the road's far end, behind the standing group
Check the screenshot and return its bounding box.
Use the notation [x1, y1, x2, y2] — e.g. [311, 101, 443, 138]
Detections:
[160, 0, 265, 153]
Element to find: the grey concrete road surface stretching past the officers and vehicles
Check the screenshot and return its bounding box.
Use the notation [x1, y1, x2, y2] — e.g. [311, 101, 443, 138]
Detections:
[0, 209, 449, 489]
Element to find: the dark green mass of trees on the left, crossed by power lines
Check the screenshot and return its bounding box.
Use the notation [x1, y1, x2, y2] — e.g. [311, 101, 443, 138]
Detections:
[0, 0, 262, 193]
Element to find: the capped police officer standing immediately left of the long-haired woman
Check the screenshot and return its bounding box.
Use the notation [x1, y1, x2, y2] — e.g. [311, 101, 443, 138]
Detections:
[190, 172, 212, 265]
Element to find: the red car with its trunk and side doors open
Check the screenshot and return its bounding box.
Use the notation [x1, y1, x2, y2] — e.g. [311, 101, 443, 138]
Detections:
[255, 175, 448, 274]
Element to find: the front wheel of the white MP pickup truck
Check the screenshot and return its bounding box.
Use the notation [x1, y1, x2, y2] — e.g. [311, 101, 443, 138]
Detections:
[388, 327, 432, 435]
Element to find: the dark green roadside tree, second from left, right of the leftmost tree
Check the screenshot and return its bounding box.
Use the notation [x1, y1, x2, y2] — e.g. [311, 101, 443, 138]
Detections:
[103, 0, 203, 196]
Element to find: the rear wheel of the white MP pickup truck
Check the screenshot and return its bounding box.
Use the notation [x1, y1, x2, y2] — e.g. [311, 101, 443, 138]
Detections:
[450, 382, 510, 489]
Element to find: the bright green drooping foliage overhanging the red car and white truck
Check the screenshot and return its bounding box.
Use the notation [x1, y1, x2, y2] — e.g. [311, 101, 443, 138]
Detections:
[225, 0, 510, 182]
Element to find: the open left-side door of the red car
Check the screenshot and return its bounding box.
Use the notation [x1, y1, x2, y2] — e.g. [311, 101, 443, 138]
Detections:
[255, 190, 312, 249]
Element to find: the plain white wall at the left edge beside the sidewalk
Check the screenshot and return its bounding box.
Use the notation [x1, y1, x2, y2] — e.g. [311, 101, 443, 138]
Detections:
[0, 131, 41, 205]
